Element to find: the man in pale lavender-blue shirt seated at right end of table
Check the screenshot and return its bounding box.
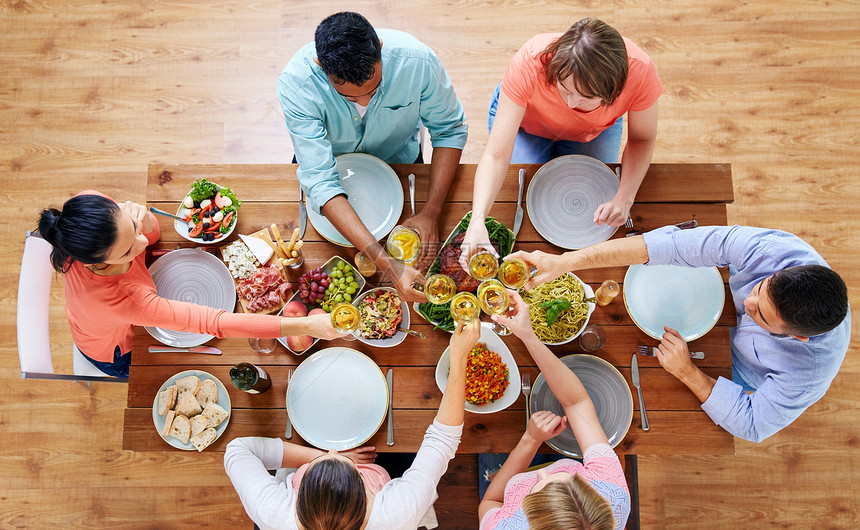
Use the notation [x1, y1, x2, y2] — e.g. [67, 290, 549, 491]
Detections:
[512, 226, 851, 442]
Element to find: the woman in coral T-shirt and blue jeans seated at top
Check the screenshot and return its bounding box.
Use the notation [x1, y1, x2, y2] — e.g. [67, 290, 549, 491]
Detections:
[461, 18, 663, 267]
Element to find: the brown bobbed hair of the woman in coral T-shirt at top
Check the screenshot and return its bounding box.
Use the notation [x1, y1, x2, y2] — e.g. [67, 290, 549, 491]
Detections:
[540, 18, 629, 106]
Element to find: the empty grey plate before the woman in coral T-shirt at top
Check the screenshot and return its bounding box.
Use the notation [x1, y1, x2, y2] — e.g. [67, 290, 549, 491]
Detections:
[526, 155, 620, 250]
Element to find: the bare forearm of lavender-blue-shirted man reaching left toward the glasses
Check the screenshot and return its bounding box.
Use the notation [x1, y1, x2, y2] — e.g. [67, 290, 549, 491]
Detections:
[506, 232, 648, 289]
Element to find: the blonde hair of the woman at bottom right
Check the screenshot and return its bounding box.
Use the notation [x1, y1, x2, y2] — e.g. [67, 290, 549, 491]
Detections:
[522, 475, 615, 530]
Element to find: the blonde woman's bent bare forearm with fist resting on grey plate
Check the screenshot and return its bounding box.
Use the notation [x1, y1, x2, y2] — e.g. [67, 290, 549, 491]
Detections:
[478, 410, 567, 520]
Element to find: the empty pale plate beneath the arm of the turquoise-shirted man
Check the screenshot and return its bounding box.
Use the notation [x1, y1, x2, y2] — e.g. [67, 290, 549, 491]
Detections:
[306, 153, 403, 247]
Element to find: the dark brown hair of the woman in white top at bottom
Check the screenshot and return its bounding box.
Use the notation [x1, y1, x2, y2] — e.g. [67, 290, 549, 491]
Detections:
[296, 458, 367, 530]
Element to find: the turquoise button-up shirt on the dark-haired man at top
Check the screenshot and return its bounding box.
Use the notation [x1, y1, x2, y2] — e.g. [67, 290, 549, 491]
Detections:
[278, 29, 467, 212]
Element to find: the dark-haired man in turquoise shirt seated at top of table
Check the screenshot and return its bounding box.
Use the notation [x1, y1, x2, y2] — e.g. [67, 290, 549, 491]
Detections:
[278, 12, 467, 302]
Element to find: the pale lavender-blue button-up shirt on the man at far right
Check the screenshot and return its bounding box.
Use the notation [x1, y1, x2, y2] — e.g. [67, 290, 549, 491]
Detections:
[644, 226, 851, 442]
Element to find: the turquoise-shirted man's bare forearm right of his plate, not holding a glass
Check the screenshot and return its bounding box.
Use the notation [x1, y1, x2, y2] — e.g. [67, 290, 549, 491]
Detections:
[403, 143, 463, 270]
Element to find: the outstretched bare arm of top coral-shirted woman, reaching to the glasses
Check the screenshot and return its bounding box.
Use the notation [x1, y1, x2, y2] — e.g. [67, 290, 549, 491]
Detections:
[460, 92, 526, 271]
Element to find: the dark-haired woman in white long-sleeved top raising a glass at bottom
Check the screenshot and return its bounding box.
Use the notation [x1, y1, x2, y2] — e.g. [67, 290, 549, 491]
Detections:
[224, 322, 481, 530]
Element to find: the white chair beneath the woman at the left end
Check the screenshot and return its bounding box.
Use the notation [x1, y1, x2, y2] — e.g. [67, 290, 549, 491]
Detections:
[18, 232, 128, 384]
